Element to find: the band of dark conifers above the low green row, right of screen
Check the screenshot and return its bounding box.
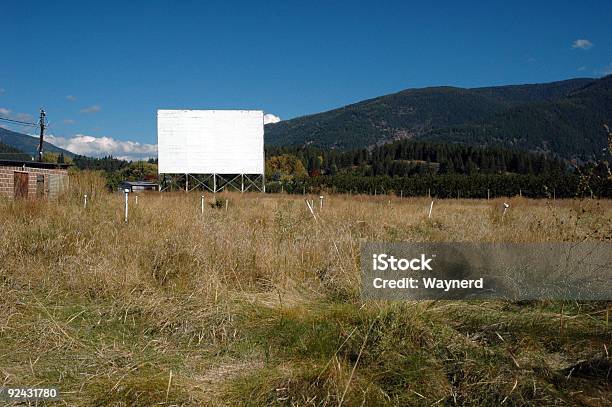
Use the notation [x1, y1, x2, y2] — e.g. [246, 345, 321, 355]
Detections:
[266, 140, 568, 177]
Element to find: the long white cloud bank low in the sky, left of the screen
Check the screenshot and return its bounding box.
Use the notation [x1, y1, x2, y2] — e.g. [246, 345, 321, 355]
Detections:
[46, 134, 157, 160]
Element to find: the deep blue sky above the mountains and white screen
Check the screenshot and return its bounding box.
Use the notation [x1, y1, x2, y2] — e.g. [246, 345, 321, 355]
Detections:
[0, 0, 612, 157]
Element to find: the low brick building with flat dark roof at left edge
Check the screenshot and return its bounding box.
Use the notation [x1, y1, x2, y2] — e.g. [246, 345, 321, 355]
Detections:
[0, 160, 69, 199]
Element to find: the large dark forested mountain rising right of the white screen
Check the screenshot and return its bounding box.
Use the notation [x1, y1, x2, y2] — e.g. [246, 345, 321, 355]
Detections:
[266, 77, 612, 159]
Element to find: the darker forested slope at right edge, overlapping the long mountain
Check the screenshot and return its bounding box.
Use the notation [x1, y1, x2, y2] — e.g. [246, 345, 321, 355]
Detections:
[420, 76, 612, 159]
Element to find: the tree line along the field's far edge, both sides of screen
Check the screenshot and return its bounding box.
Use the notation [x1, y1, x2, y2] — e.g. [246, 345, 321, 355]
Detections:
[62, 140, 612, 198]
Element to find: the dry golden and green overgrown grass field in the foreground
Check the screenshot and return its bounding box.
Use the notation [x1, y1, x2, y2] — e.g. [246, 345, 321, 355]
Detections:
[0, 174, 612, 406]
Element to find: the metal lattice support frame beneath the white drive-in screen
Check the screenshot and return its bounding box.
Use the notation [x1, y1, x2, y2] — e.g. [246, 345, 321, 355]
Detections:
[158, 174, 266, 194]
